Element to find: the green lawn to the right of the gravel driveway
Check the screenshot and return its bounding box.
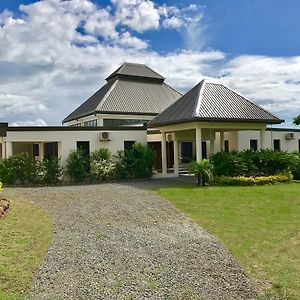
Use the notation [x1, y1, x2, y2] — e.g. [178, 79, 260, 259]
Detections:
[158, 183, 300, 299]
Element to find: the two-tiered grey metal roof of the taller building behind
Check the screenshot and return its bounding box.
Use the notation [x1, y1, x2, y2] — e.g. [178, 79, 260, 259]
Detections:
[63, 63, 182, 123]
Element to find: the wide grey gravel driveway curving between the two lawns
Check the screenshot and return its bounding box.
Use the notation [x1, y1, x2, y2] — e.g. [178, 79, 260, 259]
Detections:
[7, 180, 256, 300]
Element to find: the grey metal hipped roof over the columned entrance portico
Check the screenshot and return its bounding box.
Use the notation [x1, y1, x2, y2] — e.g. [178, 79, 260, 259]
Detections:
[149, 80, 283, 127]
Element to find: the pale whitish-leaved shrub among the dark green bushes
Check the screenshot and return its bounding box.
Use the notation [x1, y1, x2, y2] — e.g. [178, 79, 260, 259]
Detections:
[91, 159, 116, 181]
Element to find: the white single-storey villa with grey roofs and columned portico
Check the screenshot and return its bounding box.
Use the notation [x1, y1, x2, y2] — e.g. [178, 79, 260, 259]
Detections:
[0, 63, 300, 175]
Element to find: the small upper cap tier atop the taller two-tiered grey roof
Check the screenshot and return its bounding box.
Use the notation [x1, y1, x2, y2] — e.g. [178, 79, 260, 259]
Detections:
[106, 62, 164, 81]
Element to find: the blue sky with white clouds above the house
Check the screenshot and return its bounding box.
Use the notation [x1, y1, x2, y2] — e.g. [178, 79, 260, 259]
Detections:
[0, 0, 300, 127]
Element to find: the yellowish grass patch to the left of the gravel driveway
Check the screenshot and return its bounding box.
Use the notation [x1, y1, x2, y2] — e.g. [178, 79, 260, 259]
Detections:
[0, 199, 52, 300]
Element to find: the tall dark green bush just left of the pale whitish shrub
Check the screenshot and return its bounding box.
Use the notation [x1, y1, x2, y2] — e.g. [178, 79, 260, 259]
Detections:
[66, 149, 90, 182]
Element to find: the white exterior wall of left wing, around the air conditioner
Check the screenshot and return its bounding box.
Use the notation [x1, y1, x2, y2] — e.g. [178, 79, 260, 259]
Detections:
[3, 130, 146, 164]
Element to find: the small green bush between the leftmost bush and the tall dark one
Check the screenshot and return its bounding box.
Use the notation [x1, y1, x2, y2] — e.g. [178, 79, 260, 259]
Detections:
[39, 157, 63, 184]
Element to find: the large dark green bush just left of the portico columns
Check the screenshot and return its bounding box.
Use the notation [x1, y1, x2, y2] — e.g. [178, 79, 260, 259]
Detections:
[116, 143, 155, 178]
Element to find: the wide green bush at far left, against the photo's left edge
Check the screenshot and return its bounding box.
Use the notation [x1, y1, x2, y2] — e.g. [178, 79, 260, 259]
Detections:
[0, 153, 39, 185]
